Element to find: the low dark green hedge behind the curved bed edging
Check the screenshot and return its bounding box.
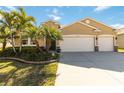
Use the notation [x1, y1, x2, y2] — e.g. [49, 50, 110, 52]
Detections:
[0, 46, 59, 61]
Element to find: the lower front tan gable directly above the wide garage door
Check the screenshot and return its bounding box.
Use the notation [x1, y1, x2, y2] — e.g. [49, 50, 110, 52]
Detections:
[61, 22, 94, 35]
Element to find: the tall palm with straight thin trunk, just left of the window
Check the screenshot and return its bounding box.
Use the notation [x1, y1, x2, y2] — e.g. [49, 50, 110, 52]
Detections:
[15, 7, 35, 52]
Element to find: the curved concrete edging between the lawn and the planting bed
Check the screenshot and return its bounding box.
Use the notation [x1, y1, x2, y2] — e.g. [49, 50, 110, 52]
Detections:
[0, 57, 57, 64]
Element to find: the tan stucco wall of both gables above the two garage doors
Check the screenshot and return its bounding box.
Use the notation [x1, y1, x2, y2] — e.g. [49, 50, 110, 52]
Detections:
[61, 19, 117, 36]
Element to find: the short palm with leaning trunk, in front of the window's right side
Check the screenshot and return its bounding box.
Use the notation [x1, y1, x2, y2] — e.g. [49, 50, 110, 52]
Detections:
[24, 26, 43, 52]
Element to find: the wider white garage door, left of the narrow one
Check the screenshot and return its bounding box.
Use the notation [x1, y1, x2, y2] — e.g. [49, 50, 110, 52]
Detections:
[60, 35, 94, 52]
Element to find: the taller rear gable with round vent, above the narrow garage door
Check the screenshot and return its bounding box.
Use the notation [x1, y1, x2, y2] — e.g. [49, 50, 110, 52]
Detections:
[81, 18, 116, 34]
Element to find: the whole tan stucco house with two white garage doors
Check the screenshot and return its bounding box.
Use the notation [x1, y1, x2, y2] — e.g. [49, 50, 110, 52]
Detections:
[4, 18, 117, 52]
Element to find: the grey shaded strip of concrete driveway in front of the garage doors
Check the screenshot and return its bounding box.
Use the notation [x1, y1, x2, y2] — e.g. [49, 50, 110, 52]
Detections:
[60, 52, 124, 72]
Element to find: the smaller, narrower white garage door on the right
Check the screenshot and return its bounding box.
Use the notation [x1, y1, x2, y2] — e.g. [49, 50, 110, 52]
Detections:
[98, 36, 113, 51]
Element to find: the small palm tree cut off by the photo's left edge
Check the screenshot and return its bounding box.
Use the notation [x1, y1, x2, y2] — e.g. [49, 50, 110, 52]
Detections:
[0, 25, 10, 51]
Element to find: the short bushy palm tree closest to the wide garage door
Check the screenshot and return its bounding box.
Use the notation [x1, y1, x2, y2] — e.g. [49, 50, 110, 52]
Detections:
[42, 26, 62, 51]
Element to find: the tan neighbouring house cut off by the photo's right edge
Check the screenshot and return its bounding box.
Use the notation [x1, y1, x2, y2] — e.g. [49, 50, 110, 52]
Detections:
[117, 28, 124, 48]
